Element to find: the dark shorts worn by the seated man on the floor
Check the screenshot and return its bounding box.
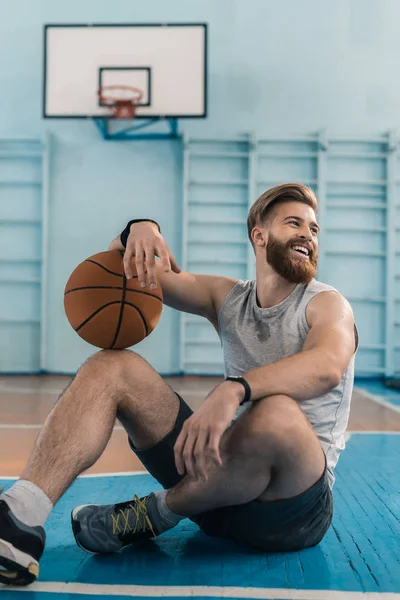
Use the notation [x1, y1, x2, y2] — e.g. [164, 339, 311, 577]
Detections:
[130, 394, 333, 552]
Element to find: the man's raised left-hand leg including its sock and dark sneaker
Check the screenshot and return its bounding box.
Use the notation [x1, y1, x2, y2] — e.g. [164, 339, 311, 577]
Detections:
[0, 351, 179, 585]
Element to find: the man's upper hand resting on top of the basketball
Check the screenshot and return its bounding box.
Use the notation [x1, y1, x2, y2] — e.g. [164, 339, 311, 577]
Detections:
[124, 222, 181, 289]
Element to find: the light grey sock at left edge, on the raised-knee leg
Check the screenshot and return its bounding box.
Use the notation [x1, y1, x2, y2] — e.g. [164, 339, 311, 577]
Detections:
[0, 479, 53, 527]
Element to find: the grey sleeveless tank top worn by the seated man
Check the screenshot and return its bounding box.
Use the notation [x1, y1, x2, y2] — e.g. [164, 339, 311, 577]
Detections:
[218, 279, 355, 487]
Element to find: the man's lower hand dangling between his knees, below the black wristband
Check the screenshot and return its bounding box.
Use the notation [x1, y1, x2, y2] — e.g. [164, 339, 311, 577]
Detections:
[174, 381, 244, 480]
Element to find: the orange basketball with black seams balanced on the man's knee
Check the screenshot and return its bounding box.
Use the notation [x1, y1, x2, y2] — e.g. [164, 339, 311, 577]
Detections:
[64, 250, 163, 349]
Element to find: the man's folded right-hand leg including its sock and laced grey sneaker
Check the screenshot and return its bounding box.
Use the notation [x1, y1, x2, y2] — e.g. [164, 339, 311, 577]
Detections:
[73, 384, 325, 552]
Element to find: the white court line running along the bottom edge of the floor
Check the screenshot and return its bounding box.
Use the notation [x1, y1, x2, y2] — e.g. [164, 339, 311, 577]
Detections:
[3, 581, 400, 600]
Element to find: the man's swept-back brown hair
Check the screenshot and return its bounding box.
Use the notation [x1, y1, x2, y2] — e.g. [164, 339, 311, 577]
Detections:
[247, 183, 318, 245]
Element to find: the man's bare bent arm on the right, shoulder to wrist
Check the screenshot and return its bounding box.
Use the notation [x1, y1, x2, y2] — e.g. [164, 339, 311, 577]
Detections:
[230, 292, 356, 401]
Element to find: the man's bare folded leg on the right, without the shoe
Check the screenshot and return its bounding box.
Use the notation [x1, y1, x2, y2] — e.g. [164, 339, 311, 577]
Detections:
[167, 396, 325, 516]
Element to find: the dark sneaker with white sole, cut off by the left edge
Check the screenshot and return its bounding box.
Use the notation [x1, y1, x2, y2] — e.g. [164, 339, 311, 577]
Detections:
[0, 500, 46, 585]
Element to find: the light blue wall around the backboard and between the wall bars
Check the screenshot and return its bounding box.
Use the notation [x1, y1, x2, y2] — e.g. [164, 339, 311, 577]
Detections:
[0, 0, 400, 373]
